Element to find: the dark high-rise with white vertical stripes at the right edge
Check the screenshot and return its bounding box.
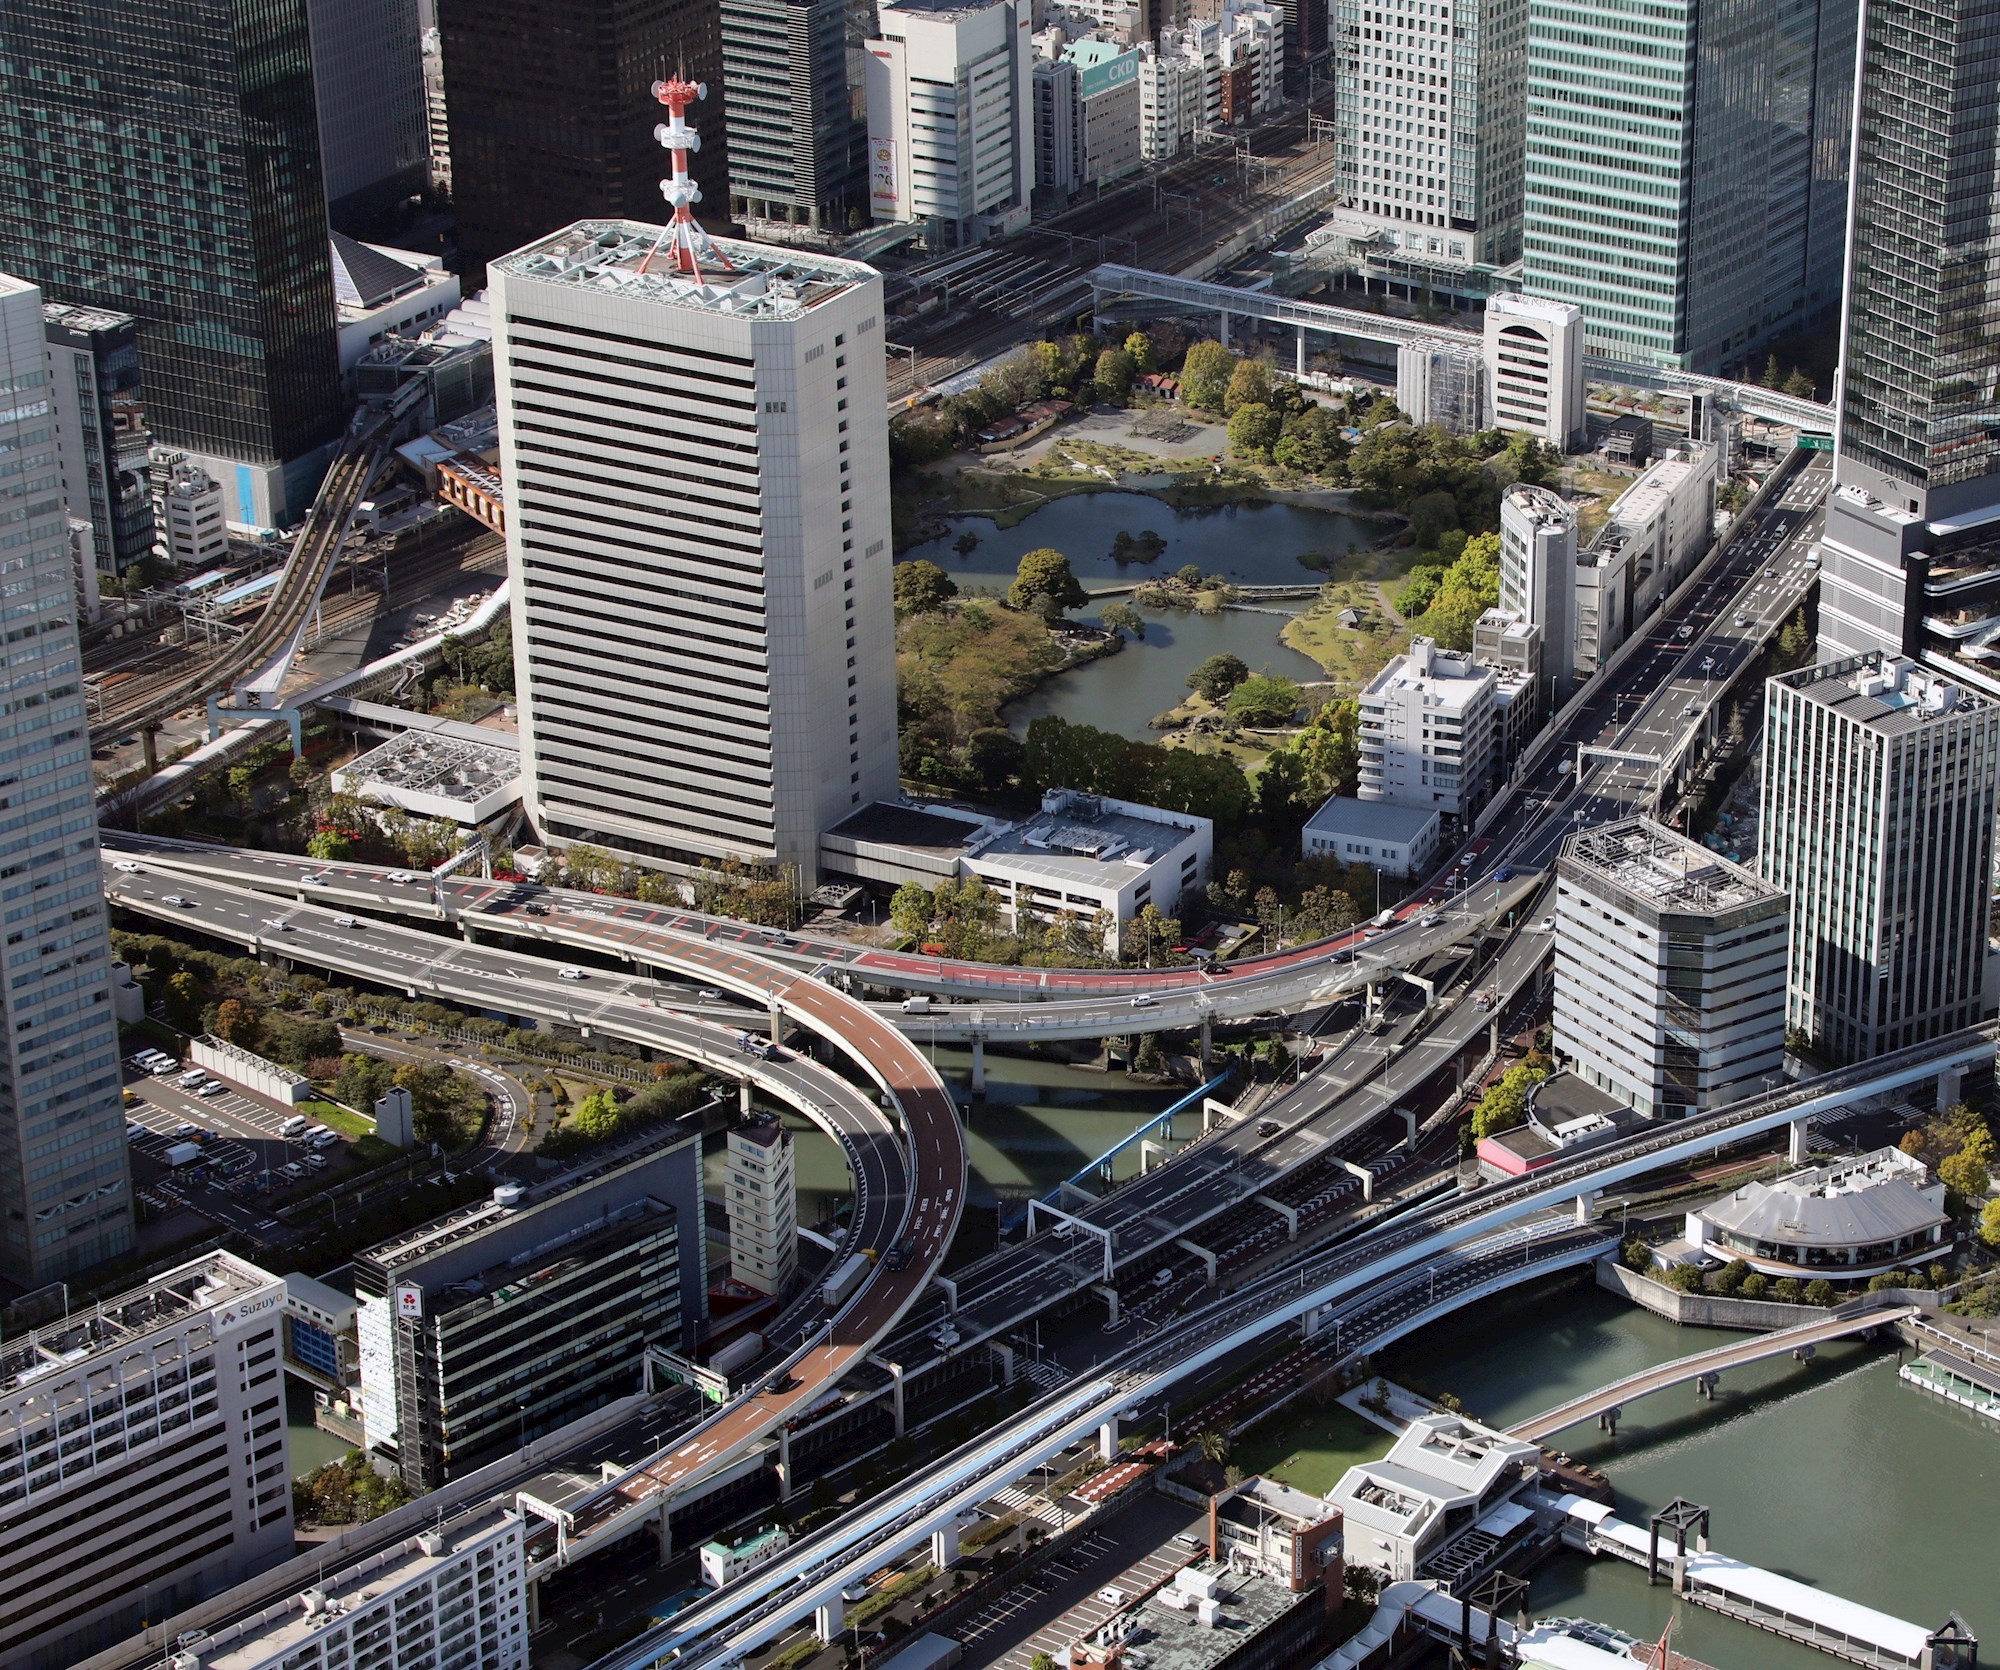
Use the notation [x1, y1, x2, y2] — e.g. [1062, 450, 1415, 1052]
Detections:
[1758, 654, 2000, 1062]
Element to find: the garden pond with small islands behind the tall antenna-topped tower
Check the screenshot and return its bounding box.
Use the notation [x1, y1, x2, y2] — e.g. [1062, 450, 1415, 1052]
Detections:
[902, 492, 1374, 740]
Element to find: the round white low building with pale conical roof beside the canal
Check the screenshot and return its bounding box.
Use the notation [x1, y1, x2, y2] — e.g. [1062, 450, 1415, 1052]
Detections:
[1686, 1148, 1952, 1282]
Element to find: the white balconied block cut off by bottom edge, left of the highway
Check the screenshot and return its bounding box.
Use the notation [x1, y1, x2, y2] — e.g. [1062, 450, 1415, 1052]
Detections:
[188, 1504, 528, 1670]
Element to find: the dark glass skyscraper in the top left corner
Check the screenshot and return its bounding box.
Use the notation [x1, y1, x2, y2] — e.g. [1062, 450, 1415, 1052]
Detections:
[0, 0, 340, 526]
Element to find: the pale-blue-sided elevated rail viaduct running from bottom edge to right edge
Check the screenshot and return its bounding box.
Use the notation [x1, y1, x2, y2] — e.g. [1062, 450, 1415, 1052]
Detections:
[598, 1024, 2000, 1670]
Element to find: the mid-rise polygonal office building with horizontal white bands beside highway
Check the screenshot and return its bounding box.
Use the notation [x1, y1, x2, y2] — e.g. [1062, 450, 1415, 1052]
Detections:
[1556, 818, 1792, 1118]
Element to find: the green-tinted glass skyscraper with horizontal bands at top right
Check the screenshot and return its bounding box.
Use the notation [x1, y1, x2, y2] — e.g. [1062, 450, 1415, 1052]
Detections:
[1522, 0, 1858, 372]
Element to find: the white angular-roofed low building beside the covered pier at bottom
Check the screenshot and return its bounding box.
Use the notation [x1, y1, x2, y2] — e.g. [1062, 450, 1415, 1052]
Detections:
[1328, 1414, 1542, 1580]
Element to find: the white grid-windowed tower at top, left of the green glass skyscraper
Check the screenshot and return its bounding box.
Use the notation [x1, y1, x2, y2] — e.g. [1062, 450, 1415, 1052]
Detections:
[1334, 0, 1528, 268]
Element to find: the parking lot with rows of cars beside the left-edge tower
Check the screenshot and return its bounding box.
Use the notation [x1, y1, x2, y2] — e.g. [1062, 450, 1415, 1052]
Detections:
[124, 1060, 364, 1244]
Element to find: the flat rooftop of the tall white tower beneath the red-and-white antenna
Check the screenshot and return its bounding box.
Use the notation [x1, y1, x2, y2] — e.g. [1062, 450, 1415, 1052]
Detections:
[496, 220, 878, 318]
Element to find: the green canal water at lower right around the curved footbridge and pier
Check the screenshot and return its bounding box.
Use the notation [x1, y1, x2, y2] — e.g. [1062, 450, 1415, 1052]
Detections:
[1382, 1286, 2000, 1670]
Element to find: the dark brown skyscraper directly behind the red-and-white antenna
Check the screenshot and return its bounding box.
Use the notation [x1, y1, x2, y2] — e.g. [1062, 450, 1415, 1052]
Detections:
[438, 0, 730, 274]
